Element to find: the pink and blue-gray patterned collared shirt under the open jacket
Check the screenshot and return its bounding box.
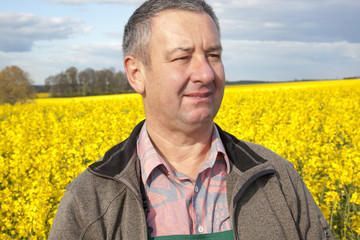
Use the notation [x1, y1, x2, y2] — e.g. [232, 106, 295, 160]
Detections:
[137, 123, 232, 237]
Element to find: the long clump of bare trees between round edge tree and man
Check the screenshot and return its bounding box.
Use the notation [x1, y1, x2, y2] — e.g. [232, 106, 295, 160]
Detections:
[45, 67, 134, 97]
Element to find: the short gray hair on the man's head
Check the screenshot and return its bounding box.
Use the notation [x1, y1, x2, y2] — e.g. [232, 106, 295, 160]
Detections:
[122, 0, 220, 66]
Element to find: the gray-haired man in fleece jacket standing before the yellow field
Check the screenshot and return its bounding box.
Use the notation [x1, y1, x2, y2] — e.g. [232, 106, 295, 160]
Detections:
[49, 0, 333, 239]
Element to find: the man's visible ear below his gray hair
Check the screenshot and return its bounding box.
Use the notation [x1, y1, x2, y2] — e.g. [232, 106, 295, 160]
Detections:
[124, 55, 145, 95]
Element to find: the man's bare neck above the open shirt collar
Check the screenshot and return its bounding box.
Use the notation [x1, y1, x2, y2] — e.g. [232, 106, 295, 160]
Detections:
[146, 120, 213, 179]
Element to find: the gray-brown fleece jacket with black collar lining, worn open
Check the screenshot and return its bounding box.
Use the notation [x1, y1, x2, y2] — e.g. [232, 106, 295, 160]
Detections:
[49, 123, 334, 240]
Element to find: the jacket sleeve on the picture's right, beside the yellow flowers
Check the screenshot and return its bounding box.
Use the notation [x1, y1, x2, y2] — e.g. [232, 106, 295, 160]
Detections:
[288, 165, 334, 240]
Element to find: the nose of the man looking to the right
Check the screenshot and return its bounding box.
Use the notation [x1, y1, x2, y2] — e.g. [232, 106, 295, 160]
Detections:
[191, 56, 215, 85]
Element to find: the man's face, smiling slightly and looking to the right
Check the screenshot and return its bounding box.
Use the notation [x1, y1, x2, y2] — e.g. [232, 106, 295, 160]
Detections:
[143, 10, 225, 129]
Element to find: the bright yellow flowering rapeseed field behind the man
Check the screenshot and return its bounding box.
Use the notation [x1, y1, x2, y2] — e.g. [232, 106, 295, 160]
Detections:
[0, 80, 360, 239]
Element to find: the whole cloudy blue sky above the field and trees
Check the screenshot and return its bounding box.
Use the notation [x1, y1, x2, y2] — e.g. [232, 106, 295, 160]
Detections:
[0, 0, 360, 84]
